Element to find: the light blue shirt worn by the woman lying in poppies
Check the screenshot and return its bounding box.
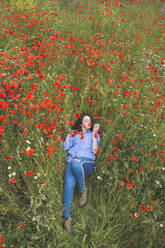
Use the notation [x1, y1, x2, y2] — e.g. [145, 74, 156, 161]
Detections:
[62, 130, 100, 162]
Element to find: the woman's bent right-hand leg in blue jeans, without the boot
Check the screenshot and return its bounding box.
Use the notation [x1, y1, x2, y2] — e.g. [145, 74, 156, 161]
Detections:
[71, 158, 96, 191]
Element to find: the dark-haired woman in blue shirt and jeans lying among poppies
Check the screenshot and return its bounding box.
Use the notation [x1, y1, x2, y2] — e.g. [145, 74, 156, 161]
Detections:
[63, 114, 100, 234]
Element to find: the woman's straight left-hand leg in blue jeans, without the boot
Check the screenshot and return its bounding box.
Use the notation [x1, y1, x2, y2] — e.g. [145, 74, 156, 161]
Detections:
[64, 162, 76, 217]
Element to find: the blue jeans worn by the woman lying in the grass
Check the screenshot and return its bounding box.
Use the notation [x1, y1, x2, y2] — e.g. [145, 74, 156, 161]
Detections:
[64, 157, 96, 217]
